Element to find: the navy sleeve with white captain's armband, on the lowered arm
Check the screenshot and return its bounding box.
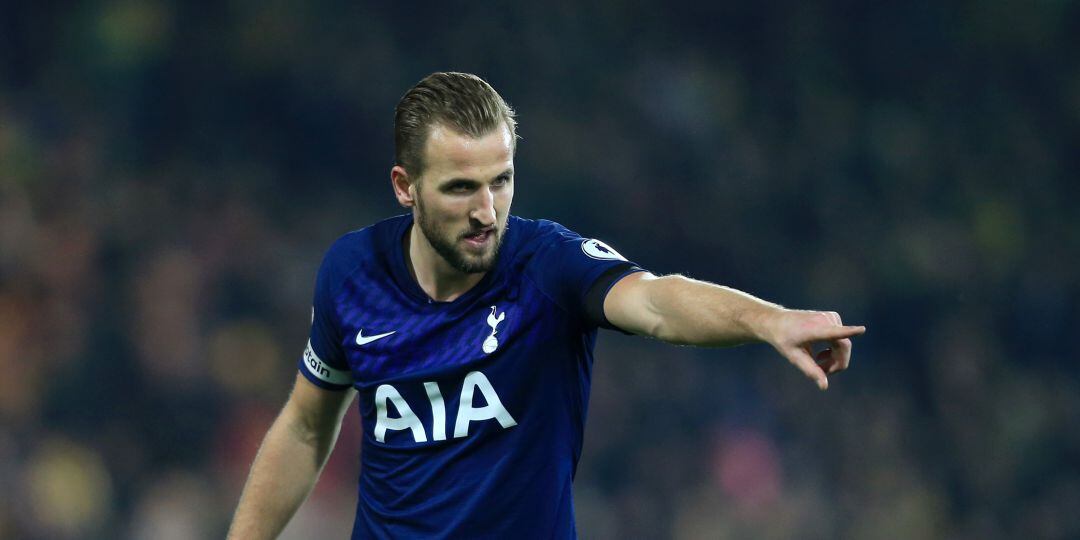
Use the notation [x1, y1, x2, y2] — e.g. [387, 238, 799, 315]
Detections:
[298, 243, 353, 390]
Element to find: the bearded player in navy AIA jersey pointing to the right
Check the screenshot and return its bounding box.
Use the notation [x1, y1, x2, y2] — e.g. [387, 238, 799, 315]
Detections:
[229, 72, 865, 539]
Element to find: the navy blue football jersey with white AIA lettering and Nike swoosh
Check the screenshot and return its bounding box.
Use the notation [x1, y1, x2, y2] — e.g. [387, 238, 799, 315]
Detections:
[299, 215, 639, 538]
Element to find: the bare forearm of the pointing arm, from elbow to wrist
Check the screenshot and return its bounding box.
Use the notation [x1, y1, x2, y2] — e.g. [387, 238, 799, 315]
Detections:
[648, 275, 783, 347]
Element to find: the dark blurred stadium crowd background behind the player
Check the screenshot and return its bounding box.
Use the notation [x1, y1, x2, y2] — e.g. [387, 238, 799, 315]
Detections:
[0, 0, 1080, 539]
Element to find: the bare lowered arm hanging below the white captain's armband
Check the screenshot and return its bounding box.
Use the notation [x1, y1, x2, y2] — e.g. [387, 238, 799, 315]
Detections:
[228, 375, 356, 540]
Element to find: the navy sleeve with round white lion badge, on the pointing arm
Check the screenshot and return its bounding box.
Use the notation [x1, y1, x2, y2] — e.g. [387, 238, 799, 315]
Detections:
[529, 221, 643, 328]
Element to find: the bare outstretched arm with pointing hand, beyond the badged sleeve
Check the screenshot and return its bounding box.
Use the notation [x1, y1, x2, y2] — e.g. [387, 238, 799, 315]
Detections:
[604, 272, 866, 390]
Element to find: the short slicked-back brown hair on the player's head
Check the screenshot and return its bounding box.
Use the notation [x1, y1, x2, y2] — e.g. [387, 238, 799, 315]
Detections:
[394, 71, 517, 176]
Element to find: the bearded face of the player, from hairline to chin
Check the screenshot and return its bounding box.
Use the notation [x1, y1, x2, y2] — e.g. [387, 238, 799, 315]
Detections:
[401, 124, 514, 273]
